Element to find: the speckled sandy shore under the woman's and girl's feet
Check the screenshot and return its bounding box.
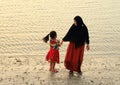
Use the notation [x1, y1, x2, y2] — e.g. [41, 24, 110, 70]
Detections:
[0, 55, 120, 85]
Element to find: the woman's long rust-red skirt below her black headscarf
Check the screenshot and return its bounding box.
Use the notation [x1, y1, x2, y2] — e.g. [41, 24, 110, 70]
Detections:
[64, 42, 84, 72]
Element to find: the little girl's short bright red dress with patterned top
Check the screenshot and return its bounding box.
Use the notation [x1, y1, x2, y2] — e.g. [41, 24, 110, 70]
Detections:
[46, 40, 60, 63]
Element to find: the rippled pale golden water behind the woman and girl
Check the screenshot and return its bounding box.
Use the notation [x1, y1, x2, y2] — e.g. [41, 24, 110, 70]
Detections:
[0, 0, 120, 57]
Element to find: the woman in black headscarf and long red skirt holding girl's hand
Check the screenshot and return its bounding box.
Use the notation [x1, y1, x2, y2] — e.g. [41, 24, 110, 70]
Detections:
[61, 16, 90, 75]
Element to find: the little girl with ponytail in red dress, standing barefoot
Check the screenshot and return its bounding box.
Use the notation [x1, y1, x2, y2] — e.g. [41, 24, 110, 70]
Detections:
[43, 31, 60, 73]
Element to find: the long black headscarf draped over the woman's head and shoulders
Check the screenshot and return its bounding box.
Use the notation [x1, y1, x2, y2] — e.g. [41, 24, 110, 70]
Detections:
[63, 16, 89, 48]
